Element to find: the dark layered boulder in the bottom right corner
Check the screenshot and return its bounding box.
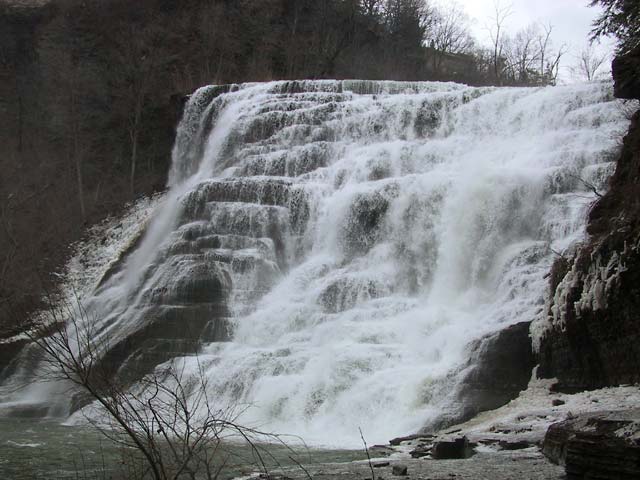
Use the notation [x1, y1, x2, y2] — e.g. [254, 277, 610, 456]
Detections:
[543, 410, 640, 480]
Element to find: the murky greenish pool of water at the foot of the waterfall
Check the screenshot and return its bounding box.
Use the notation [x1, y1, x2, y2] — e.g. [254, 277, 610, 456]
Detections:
[0, 418, 366, 480]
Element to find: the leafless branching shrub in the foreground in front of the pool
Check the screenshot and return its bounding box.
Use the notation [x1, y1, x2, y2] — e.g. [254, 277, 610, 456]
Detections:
[22, 299, 288, 480]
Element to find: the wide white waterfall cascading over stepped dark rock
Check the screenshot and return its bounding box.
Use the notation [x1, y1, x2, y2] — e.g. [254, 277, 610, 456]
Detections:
[2, 81, 627, 445]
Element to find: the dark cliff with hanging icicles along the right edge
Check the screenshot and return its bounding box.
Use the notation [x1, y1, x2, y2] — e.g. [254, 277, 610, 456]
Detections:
[538, 47, 640, 392]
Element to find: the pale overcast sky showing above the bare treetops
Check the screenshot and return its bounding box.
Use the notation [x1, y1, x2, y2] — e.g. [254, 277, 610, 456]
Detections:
[452, 0, 613, 78]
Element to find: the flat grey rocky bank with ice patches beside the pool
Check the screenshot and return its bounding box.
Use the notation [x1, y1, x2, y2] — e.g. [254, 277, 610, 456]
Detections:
[238, 379, 640, 480]
